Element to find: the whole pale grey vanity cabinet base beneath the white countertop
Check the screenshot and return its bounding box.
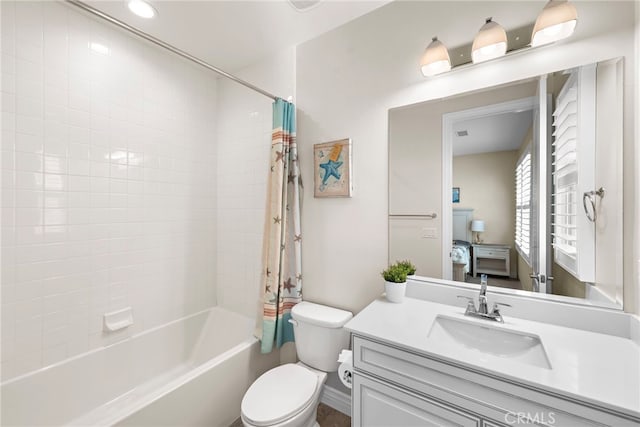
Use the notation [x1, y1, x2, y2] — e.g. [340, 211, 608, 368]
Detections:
[352, 335, 638, 427]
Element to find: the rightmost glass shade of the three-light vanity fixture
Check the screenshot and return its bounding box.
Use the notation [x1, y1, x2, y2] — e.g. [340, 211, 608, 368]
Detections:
[531, 0, 578, 47]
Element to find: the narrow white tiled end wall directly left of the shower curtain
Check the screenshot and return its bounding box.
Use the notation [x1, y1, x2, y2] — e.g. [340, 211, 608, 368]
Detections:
[217, 48, 295, 317]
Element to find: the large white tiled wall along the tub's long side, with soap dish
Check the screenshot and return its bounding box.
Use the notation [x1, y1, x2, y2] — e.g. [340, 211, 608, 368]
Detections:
[1, 1, 218, 380]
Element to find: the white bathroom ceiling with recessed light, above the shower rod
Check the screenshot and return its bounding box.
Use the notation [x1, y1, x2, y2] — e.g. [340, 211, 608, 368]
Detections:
[80, 0, 390, 72]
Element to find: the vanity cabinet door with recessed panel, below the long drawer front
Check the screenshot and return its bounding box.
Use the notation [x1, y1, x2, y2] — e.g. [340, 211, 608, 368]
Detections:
[352, 374, 481, 427]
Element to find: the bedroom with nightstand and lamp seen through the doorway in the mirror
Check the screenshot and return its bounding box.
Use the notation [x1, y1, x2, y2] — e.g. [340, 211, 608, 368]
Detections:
[444, 95, 536, 289]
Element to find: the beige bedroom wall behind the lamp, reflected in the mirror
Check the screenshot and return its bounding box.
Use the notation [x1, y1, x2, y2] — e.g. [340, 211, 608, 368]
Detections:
[452, 150, 518, 249]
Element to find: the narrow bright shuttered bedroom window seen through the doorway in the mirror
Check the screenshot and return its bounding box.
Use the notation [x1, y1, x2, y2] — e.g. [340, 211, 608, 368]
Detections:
[515, 149, 532, 265]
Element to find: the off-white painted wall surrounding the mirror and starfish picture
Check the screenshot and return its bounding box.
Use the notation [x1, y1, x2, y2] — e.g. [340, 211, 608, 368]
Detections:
[297, 2, 640, 312]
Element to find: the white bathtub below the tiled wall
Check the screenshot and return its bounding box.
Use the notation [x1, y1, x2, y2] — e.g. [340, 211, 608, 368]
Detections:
[1, 307, 279, 427]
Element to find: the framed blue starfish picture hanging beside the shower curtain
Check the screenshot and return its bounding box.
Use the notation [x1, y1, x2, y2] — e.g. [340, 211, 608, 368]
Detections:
[313, 138, 352, 197]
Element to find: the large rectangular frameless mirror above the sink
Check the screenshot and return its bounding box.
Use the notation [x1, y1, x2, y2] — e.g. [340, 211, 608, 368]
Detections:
[389, 58, 623, 308]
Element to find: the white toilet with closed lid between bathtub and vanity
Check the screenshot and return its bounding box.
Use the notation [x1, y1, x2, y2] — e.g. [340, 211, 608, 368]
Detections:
[241, 301, 353, 427]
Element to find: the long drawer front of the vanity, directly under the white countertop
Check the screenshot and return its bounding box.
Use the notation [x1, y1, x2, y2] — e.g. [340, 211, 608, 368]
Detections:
[353, 336, 637, 427]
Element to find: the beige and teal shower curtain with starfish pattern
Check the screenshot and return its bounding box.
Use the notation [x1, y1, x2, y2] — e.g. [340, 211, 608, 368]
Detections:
[256, 99, 302, 353]
